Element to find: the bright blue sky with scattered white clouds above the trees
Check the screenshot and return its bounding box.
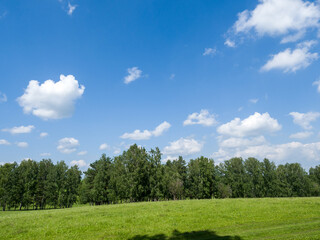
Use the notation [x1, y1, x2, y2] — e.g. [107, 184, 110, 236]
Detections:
[0, 0, 320, 169]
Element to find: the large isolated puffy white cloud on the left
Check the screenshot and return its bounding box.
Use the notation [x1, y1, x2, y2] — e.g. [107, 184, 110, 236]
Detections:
[17, 75, 85, 120]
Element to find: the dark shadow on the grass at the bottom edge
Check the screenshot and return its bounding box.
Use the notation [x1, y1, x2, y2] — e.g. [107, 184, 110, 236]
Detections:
[128, 230, 241, 240]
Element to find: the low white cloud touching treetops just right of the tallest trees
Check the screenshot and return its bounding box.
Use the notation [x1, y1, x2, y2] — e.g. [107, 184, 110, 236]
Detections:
[163, 138, 203, 156]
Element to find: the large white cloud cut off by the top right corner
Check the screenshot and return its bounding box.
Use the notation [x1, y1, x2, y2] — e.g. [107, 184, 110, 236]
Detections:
[234, 0, 320, 38]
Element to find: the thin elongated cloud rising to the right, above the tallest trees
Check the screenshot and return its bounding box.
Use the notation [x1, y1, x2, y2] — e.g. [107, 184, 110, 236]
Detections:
[121, 121, 171, 140]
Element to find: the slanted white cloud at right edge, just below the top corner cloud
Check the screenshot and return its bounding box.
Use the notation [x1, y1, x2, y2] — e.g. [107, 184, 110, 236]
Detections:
[261, 42, 318, 72]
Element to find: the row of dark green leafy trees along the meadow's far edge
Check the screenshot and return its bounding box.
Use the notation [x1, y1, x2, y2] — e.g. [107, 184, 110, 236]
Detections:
[0, 145, 320, 210]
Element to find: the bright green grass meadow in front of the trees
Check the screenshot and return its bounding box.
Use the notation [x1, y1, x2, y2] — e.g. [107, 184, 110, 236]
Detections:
[0, 198, 320, 240]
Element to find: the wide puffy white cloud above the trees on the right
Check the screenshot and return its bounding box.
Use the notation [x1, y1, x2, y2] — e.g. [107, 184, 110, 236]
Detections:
[217, 112, 281, 137]
